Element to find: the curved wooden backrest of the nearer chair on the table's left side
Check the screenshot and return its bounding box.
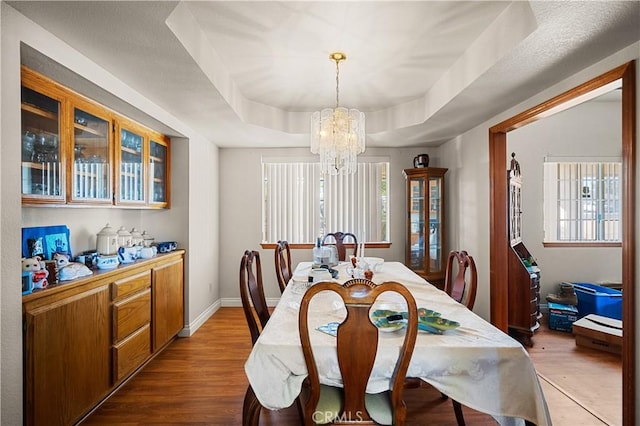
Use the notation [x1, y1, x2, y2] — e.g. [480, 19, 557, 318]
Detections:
[240, 250, 271, 345]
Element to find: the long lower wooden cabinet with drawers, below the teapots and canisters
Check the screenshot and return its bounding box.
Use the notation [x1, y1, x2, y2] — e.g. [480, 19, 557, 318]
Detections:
[22, 250, 184, 426]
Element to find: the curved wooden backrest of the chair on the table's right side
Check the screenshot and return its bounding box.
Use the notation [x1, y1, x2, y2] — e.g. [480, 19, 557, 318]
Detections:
[444, 250, 478, 309]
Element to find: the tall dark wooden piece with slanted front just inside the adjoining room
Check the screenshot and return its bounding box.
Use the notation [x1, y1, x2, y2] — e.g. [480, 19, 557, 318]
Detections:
[507, 153, 541, 346]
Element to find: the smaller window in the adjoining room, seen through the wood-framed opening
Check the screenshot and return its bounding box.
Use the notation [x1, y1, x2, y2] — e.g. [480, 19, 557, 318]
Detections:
[544, 162, 622, 243]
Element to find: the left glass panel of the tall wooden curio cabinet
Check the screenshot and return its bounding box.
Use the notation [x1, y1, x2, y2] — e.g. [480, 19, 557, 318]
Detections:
[408, 177, 426, 270]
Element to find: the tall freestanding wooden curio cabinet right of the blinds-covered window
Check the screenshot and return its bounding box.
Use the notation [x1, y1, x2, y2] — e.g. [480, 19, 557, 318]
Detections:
[404, 167, 447, 288]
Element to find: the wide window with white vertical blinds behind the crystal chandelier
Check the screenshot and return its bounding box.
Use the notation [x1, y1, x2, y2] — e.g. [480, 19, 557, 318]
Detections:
[262, 158, 389, 244]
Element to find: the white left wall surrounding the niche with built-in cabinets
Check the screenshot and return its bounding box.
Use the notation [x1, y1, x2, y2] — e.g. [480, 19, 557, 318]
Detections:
[0, 2, 220, 425]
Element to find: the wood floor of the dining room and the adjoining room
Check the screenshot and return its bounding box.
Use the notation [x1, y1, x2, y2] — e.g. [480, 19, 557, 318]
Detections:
[82, 308, 622, 426]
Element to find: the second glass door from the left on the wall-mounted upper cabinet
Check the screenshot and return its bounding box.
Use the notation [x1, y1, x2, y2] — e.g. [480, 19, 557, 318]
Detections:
[71, 104, 113, 203]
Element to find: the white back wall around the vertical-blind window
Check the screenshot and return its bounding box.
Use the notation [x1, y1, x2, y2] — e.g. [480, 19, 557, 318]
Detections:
[220, 148, 439, 305]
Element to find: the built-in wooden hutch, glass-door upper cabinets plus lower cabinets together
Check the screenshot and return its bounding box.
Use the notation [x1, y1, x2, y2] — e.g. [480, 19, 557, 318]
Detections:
[21, 66, 179, 425]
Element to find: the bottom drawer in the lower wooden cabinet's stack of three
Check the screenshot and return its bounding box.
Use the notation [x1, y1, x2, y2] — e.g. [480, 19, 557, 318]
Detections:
[113, 324, 151, 383]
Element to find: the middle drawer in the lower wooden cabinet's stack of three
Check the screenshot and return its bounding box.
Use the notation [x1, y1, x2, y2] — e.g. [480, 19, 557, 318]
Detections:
[113, 289, 151, 343]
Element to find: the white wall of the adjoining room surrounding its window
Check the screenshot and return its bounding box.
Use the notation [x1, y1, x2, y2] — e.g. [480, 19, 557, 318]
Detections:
[507, 100, 622, 303]
